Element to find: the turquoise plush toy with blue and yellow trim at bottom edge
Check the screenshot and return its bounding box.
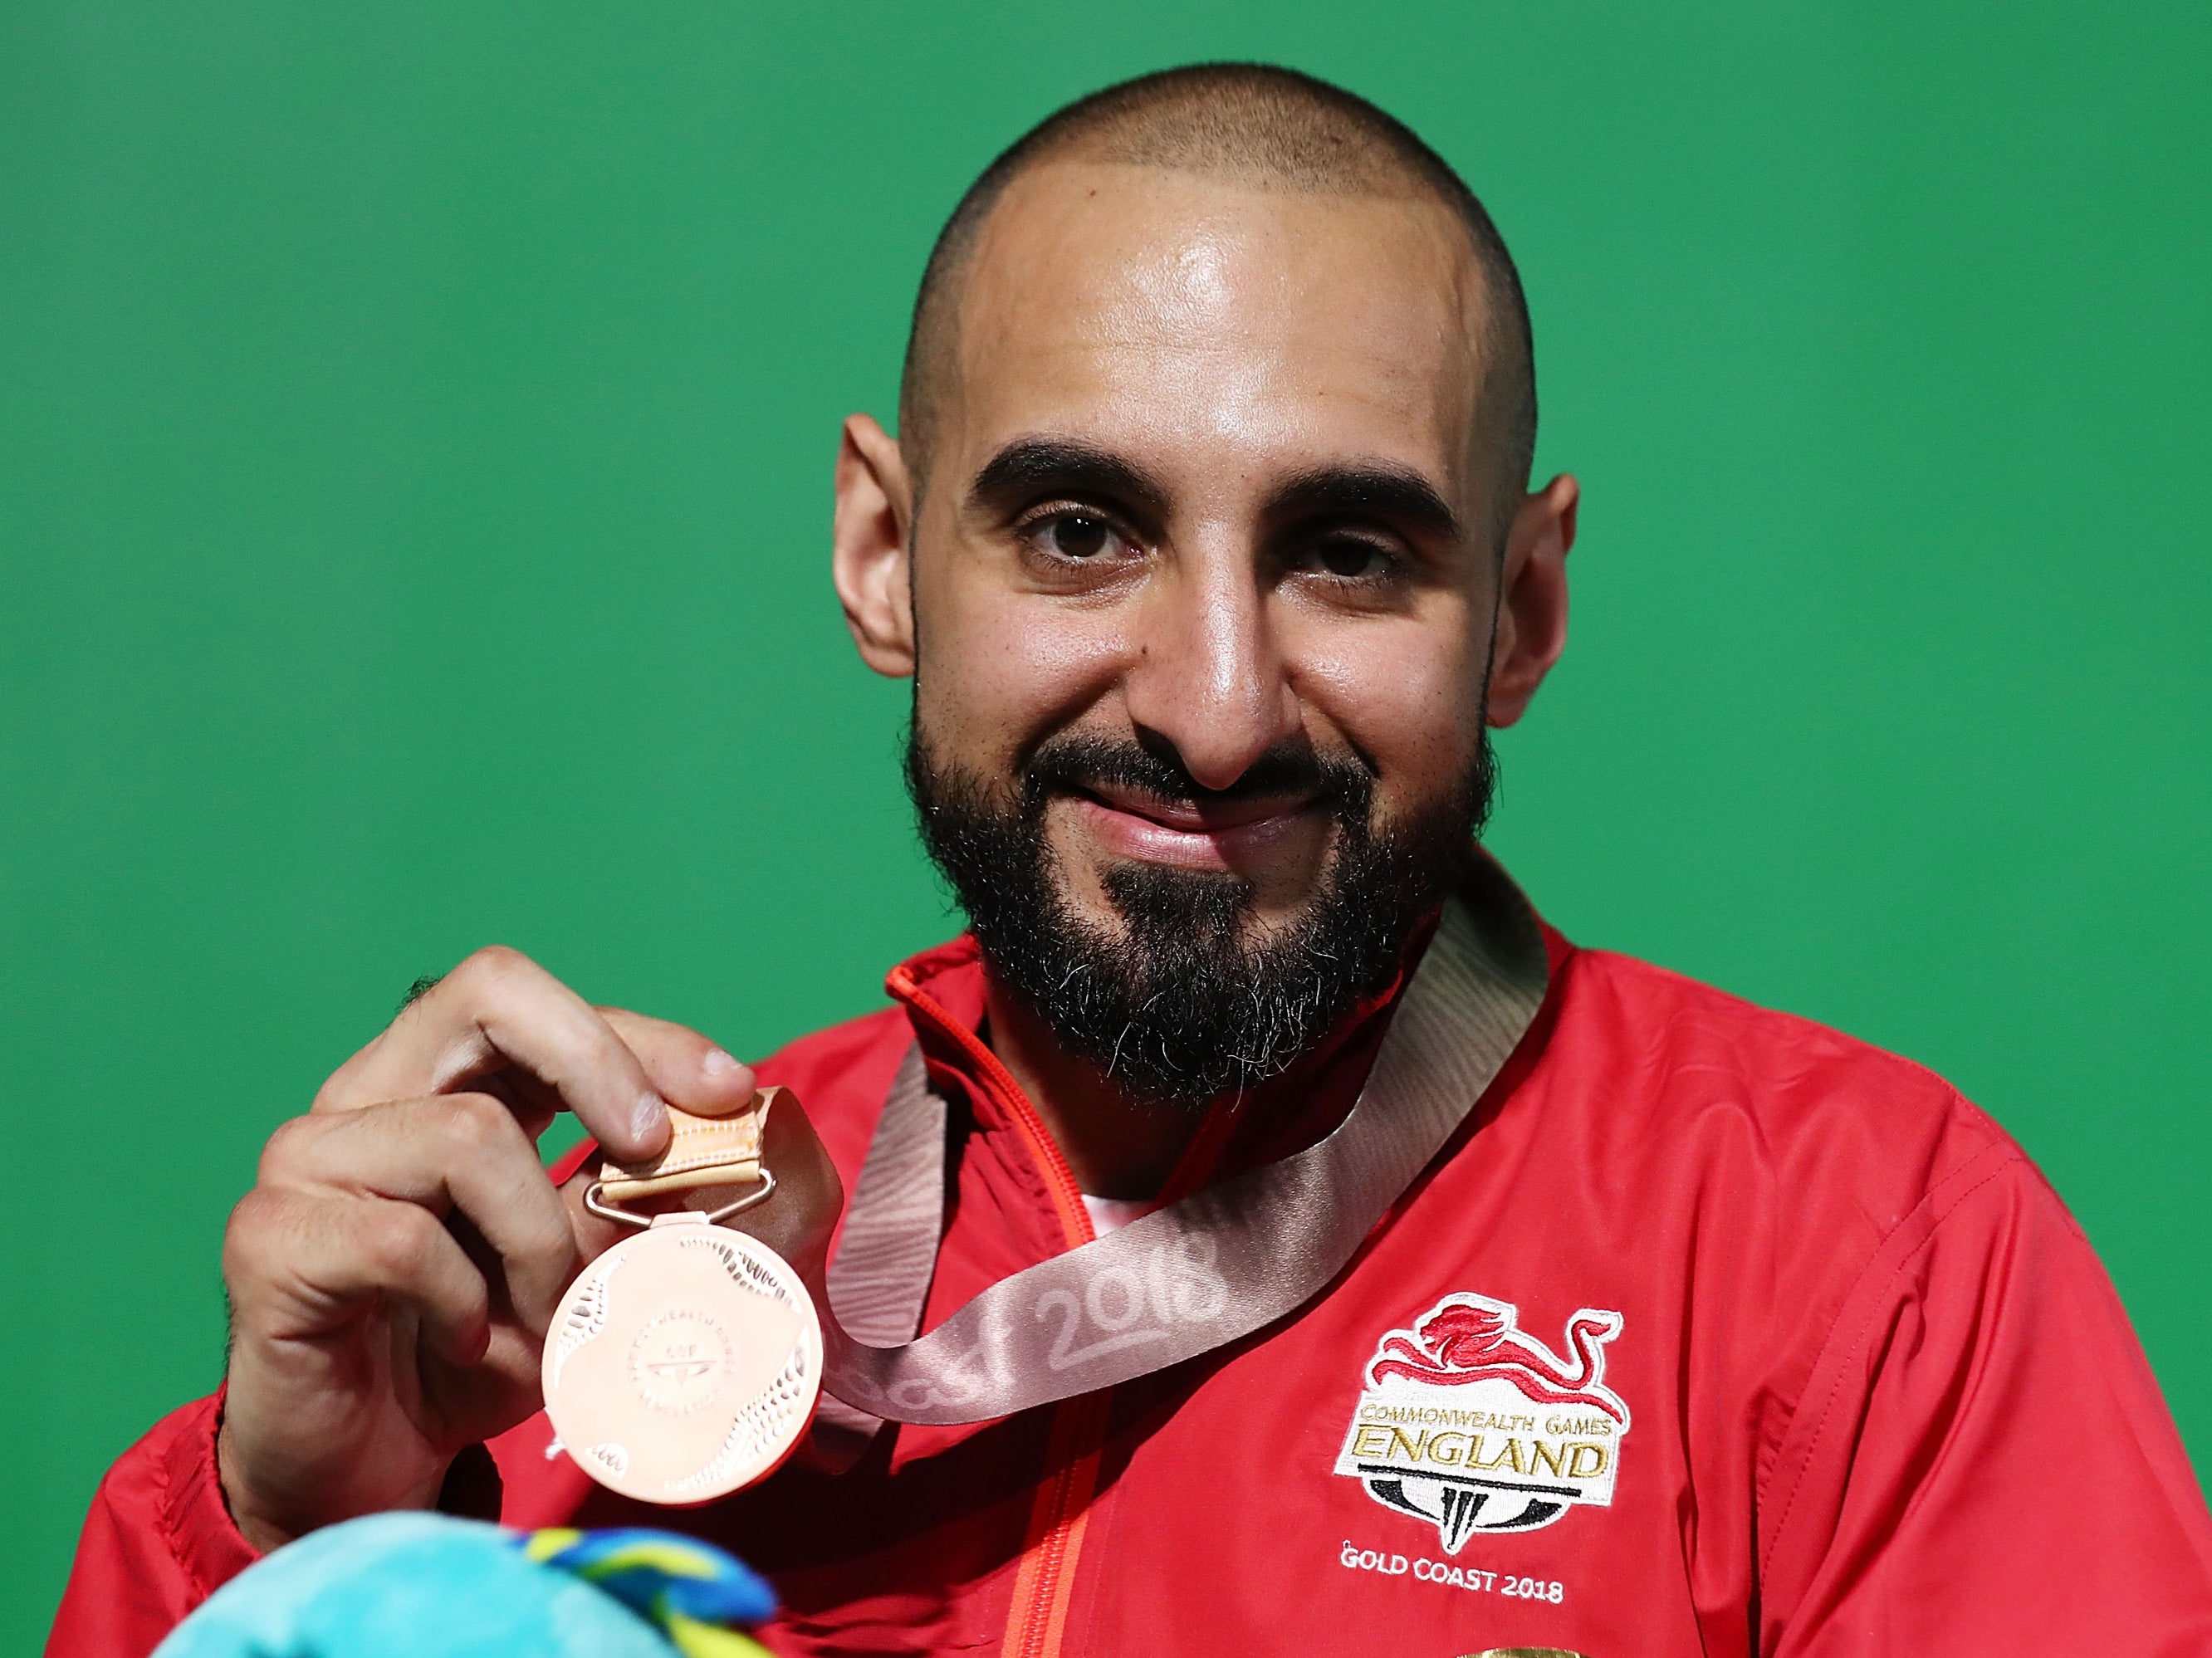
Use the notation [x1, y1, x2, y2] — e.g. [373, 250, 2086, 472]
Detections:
[154, 1514, 776, 1658]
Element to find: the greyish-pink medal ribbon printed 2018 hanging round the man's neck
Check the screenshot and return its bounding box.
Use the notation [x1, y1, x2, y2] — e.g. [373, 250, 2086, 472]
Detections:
[820, 858, 1549, 1428]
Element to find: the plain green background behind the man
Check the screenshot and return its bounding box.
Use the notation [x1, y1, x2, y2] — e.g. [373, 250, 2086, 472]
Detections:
[0, 0, 2212, 1651]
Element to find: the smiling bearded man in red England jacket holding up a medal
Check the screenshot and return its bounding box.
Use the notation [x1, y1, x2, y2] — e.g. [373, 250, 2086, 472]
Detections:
[53, 66, 2212, 1658]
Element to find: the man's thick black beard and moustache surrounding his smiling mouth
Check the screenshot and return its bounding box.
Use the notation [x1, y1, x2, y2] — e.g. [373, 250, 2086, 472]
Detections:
[907, 721, 1495, 1110]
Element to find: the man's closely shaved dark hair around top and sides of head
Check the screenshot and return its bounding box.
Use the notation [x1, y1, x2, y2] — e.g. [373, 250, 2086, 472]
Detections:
[898, 64, 1535, 544]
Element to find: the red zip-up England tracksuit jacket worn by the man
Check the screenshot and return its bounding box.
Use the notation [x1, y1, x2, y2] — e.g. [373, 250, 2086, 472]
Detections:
[49, 915, 2212, 1658]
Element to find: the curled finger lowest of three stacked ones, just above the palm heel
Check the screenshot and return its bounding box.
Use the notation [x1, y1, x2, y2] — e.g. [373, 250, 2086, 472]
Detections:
[223, 1187, 491, 1364]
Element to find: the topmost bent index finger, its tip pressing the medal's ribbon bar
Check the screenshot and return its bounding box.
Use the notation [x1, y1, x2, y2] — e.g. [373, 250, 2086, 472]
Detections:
[314, 946, 668, 1163]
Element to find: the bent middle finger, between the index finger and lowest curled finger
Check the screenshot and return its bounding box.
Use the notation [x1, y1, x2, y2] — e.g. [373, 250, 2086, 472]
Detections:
[261, 1094, 577, 1335]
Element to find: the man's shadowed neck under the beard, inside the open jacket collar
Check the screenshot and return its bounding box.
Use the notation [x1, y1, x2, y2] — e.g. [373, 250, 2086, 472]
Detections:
[984, 971, 1206, 1201]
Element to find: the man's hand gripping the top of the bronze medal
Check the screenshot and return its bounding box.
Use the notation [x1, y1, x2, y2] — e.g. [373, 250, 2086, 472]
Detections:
[217, 948, 761, 1550]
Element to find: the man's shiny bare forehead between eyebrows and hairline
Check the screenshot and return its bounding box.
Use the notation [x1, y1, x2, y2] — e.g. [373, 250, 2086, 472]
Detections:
[940, 161, 1482, 511]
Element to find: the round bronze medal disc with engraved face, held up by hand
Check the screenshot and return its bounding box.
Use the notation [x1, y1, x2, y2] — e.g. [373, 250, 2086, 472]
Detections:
[542, 1215, 823, 1505]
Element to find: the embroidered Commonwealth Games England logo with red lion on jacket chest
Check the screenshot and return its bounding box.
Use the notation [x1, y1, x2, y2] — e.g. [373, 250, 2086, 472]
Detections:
[1336, 1294, 1628, 1554]
